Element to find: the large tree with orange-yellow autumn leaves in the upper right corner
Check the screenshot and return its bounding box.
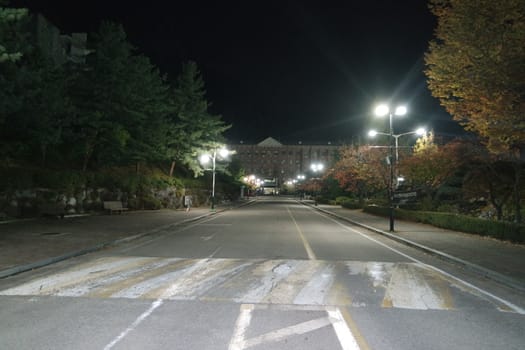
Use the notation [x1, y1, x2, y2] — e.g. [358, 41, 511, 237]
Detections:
[425, 0, 525, 222]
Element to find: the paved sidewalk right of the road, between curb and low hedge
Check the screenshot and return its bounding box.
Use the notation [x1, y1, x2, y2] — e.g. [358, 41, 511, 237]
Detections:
[314, 204, 525, 291]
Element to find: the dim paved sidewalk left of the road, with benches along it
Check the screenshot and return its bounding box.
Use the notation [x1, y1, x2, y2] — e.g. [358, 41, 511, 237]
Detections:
[0, 205, 233, 278]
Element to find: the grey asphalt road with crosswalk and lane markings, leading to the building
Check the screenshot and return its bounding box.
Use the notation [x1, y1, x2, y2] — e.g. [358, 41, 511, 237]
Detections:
[0, 198, 525, 350]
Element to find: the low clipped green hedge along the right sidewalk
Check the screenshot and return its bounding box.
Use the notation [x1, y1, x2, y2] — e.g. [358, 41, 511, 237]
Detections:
[363, 206, 525, 243]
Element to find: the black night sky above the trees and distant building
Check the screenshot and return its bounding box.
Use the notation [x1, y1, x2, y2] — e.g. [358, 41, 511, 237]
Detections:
[11, 0, 462, 142]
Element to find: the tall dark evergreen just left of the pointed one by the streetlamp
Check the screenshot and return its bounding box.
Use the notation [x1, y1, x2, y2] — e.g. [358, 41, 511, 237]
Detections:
[66, 22, 170, 170]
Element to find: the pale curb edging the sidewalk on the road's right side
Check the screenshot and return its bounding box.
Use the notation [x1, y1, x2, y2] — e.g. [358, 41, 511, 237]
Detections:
[301, 202, 525, 292]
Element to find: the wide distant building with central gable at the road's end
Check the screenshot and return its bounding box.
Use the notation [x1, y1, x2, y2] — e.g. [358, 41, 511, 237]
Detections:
[228, 137, 340, 191]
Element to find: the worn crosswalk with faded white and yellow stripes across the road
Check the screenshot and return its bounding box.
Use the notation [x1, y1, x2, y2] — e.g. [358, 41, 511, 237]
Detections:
[0, 257, 508, 310]
